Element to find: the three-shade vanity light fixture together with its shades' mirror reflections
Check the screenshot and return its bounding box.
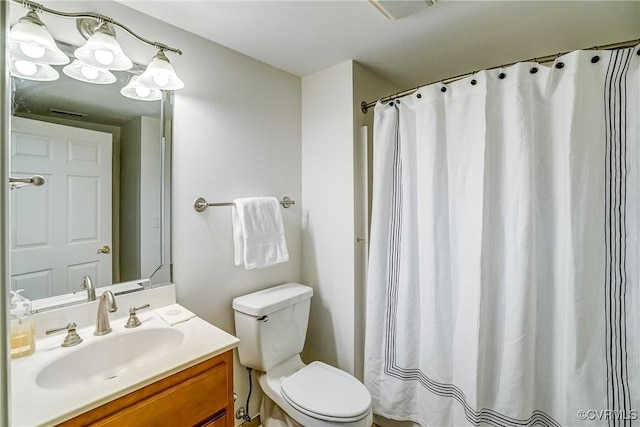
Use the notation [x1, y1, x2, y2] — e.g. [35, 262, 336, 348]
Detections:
[9, 0, 184, 100]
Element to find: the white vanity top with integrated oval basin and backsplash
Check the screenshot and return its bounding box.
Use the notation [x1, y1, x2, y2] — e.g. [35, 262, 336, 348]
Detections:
[11, 298, 239, 426]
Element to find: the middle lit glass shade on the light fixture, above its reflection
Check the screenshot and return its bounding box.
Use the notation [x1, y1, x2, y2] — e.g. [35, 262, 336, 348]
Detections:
[74, 29, 133, 70]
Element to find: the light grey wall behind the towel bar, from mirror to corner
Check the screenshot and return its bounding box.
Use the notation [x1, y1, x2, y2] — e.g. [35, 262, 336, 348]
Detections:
[171, 11, 302, 422]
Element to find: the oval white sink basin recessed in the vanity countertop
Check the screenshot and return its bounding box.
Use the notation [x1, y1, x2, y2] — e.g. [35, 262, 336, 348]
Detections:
[36, 328, 185, 389]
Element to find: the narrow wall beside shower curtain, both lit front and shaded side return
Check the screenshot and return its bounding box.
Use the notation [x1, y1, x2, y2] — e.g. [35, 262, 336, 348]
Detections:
[302, 61, 395, 378]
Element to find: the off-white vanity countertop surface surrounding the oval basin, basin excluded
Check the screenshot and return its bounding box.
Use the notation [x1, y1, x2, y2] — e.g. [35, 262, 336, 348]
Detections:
[11, 304, 239, 427]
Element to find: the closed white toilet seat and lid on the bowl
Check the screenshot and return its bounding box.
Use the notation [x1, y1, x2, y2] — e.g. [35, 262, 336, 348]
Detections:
[281, 361, 371, 423]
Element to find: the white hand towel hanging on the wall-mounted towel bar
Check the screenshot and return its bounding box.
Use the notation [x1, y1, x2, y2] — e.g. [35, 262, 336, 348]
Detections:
[232, 197, 289, 270]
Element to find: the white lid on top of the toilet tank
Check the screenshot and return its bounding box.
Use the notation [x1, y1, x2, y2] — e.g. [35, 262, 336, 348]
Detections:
[233, 283, 313, 316]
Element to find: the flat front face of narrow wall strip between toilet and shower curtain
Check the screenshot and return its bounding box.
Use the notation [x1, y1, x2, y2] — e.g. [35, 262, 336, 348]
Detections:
[302, 61, 355, 373]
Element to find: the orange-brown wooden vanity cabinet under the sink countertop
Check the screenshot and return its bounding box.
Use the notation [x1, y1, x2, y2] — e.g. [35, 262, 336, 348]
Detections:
[59, 350, 233, 427]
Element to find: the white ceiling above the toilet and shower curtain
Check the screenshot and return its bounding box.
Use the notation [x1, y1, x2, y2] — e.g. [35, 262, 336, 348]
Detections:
[119, 0, 640, 89]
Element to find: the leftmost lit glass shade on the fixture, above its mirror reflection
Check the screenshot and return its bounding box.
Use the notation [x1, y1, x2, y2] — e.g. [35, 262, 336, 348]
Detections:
[9, 11, 69, 65]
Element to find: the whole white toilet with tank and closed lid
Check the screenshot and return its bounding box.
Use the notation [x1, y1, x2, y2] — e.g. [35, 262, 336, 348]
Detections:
[233, 283, 373, 427]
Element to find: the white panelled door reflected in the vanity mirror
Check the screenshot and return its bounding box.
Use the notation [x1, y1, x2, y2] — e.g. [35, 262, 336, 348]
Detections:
[10, 117, 112, 299]
